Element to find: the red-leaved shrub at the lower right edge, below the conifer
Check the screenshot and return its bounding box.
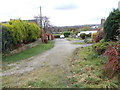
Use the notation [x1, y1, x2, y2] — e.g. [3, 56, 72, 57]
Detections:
[104, 40, 120, 78]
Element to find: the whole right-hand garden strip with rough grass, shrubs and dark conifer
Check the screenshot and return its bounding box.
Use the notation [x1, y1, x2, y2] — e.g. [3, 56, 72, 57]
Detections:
[68, 9, 120, 88]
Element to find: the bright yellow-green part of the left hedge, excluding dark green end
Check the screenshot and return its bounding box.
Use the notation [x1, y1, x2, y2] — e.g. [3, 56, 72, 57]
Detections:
[4, 20, 40, 45]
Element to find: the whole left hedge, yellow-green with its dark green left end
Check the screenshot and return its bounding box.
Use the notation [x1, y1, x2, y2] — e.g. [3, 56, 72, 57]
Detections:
[2, 20, 40, 53]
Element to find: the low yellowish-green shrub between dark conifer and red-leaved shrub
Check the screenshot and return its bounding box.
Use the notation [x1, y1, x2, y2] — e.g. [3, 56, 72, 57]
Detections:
[92, 39, 115, 55]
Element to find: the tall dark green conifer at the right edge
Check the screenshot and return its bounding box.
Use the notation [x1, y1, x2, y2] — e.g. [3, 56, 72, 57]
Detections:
[104, 9, 120, 41]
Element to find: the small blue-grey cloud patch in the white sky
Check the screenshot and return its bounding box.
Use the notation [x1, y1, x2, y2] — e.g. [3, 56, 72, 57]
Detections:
[54, 3, 78, 10]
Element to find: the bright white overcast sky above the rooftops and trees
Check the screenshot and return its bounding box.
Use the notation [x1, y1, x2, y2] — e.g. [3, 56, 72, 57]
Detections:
[0, 0, 120, 26]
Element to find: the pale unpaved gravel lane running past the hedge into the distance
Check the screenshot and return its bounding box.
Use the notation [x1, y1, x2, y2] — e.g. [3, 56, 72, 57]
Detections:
[1, 39, 90, 87]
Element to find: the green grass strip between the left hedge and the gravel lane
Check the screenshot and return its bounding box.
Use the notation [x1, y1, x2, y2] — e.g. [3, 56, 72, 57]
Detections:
[2, 41, 54, 63]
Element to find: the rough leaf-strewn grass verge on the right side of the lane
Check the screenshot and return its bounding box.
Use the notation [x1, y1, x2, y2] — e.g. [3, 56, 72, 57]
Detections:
[68, 47, 119, 88]
